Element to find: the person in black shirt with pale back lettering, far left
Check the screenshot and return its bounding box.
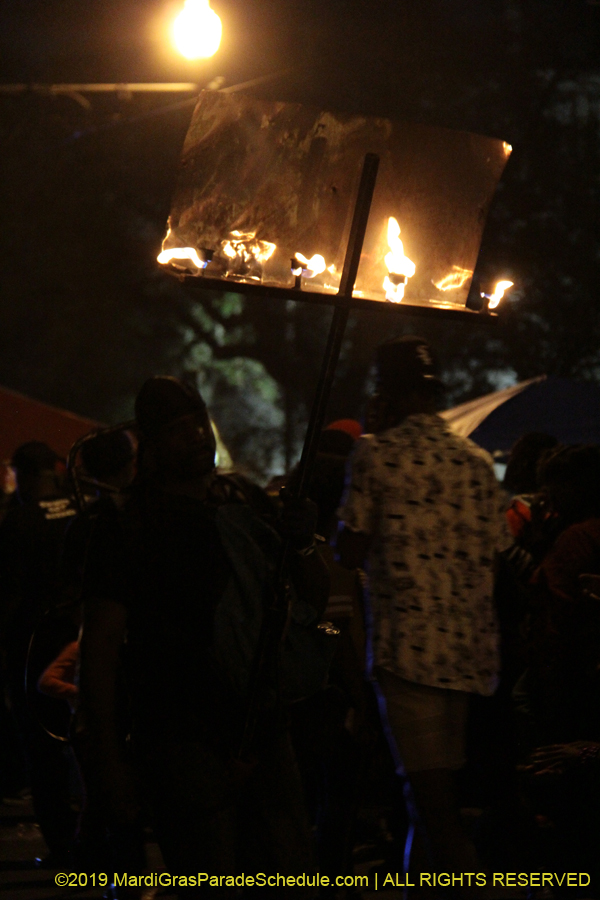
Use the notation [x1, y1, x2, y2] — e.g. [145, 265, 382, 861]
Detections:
[0, 441, 76, 864]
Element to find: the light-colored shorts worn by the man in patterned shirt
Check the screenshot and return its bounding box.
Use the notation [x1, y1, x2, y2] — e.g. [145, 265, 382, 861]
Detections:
[374, 668, 469, 772]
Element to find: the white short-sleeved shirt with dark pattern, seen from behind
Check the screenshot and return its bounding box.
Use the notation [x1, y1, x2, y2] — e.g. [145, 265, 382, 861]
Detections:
[339, 414, 510, 695]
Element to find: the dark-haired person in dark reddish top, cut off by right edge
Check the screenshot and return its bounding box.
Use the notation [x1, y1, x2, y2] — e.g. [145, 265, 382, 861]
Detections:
[521, 445, 600, 744]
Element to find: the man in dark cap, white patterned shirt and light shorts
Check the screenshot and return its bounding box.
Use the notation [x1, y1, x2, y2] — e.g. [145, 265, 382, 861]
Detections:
[339, 336, 508, 893]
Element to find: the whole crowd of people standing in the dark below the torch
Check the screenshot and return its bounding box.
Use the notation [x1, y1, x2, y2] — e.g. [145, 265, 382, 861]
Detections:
[0, 336, 600, 898]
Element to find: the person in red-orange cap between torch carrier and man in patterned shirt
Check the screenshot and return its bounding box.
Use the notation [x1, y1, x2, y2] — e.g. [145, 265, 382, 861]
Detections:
[290, 419, 378, 894]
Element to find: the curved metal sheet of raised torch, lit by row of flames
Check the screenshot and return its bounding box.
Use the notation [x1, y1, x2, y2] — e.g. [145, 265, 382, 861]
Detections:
[159, 91, 511, 309]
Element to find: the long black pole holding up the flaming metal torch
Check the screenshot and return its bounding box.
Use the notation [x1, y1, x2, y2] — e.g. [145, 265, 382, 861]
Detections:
[238, 153, 379, 760]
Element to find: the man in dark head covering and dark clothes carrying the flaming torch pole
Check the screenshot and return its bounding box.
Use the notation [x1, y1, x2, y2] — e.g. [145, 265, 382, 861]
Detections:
[81, 377, 328, 896]
